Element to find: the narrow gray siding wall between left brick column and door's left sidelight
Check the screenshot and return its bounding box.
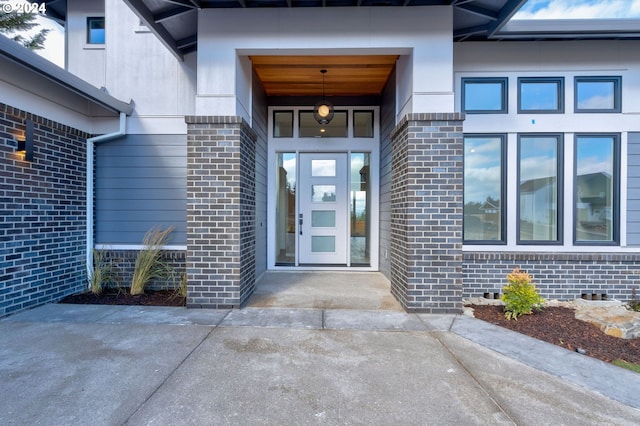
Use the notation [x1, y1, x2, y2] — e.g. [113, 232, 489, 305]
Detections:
[251, 70, 268, 277]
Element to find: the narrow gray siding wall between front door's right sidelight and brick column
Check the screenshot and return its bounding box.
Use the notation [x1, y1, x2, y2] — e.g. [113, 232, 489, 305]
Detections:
[379, 68, 396, 279]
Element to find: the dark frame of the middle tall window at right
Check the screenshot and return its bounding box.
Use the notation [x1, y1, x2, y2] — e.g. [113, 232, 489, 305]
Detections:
[515, 133, 564, 246]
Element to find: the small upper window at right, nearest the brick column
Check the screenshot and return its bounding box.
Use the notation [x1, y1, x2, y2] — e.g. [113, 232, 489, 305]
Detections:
[462, 77, 508, 114]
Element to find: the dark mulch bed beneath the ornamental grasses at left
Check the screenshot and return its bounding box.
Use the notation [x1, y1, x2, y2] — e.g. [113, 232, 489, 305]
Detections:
[60, 289, 185, 306]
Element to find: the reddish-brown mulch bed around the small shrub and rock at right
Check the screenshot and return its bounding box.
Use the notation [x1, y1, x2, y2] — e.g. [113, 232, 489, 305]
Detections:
[472, 305, 640, 364]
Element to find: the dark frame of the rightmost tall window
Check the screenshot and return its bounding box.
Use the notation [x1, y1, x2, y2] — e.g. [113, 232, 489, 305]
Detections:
[572, 133, 621, 246]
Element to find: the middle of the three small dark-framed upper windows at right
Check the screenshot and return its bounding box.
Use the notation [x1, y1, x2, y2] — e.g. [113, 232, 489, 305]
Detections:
[518, 77, 564, 113]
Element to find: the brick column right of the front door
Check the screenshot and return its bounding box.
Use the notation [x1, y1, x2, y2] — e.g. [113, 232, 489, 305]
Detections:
[391, 113, 464, 313]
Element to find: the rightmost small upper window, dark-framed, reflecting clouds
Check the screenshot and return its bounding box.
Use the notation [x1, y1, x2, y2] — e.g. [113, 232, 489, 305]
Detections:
[575, 77, 622, 112]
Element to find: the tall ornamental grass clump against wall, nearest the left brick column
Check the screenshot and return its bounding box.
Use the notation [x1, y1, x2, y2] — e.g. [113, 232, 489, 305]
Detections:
[131, 226, 174, 295]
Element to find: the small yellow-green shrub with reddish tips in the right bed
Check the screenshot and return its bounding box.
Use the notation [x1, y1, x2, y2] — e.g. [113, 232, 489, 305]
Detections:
[502, 268, 544, 320]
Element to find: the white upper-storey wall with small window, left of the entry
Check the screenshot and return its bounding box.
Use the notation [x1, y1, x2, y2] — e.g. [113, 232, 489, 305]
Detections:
[67, 0, 196, 134]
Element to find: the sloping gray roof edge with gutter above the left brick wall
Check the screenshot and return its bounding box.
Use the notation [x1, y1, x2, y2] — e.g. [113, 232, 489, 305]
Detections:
[0, 35, 134, 115]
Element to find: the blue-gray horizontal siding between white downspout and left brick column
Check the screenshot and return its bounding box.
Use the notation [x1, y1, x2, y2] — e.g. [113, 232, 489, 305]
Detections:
[95, 135, 187, 245]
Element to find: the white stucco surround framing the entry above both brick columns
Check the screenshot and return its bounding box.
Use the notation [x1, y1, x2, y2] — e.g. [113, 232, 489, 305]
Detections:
[196, 6, 454, 121]
